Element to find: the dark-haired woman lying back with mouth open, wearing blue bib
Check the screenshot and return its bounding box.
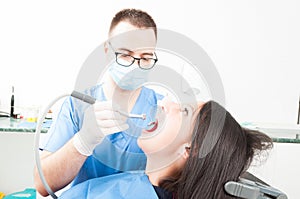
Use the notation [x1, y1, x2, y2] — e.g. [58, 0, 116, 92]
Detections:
[61, 100, 272, 199]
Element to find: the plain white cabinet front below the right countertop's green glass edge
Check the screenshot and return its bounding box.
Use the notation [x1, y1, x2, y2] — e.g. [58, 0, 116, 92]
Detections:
[249, 143, 300, 199]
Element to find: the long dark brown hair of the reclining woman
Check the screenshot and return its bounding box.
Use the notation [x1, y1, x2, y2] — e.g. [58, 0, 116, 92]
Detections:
[160, 101, 273, 199]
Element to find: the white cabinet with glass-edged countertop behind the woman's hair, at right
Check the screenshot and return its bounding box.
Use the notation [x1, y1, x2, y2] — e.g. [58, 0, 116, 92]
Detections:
[241, 122, 300, 199]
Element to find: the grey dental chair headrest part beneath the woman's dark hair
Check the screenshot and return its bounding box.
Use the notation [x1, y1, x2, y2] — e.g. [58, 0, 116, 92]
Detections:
[224, 172, 288, 199]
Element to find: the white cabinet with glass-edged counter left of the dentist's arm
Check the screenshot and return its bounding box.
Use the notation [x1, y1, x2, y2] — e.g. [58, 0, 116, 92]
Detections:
[0, 117, 47, 195]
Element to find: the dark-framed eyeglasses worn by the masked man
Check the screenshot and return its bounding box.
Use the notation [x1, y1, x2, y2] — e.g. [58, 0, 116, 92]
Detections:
[108, 42, 158, 70]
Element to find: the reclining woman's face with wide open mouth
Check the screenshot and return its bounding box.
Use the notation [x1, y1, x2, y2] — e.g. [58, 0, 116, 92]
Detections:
[138, 99, 200, 155]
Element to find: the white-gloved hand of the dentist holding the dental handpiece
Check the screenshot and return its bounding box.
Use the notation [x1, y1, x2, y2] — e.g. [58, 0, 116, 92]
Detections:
[73, 101, 129, 156]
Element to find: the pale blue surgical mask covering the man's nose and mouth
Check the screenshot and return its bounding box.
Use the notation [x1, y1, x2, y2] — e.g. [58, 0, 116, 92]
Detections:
[108, 62, 149, 90]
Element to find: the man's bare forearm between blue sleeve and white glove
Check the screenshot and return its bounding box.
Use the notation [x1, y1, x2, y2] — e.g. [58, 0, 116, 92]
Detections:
[34, 138, 87, 196]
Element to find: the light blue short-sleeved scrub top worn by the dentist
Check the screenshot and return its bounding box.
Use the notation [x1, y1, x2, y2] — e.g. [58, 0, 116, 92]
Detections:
[40, 85, 162, 185]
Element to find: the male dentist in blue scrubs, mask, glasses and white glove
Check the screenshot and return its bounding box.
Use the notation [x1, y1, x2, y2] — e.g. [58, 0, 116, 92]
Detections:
[34, 9, 162, 196]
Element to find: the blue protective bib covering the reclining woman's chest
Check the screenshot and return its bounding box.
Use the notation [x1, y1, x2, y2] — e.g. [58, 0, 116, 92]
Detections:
[59, 173, 158, 199]
